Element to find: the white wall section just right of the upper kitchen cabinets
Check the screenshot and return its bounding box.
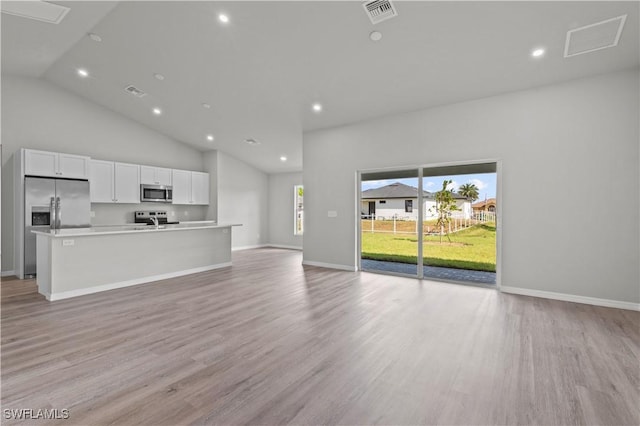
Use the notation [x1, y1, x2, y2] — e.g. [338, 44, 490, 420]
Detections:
[217, 151, 269, 249]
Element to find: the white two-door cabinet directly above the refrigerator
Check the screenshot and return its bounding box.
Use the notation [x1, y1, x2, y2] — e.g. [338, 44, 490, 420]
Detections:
[24, 149, 91, 179]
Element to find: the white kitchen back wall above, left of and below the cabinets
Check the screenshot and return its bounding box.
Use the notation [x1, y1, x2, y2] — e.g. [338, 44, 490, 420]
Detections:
[2, 75, 206, 271]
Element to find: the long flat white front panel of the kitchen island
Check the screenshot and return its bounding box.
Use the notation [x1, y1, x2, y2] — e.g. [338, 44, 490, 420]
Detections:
[51, 227, 231, 300]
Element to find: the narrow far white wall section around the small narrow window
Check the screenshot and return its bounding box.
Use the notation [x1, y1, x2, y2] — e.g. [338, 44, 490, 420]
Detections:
[269, 172, 306, 249]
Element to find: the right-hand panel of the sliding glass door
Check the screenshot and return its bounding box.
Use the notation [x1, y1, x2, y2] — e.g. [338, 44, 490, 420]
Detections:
[422, 163, 497, 284]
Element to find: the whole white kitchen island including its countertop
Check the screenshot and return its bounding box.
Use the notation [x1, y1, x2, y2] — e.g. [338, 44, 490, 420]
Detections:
[34, 222, 239, 301]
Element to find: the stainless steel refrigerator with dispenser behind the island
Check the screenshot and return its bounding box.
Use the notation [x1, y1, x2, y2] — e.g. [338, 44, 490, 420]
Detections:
[24, 177, 91, 275]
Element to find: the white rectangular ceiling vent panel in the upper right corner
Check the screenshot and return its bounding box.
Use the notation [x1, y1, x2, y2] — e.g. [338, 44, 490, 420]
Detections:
[564, 15, 627, 58]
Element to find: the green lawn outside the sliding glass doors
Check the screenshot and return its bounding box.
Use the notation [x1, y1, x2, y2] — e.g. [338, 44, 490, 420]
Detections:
[362, 224, 496, 272]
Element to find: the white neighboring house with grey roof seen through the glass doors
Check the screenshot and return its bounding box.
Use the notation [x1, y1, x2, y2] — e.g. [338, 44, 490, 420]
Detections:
[360, 182, 471, 220]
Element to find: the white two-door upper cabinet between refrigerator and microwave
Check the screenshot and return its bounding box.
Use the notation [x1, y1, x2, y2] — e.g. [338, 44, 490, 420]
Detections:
[89, 160, 140, 204]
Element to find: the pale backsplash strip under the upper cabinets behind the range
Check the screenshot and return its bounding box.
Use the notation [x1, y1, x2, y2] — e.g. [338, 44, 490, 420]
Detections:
[91, 203, 207, 226]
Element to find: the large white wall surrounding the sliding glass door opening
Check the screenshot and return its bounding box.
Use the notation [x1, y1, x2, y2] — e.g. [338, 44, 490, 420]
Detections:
[303, 69, 640, 303]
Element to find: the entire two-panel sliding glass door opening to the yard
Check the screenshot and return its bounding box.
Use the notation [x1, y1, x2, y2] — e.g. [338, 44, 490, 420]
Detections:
[358, 162, 499, 286]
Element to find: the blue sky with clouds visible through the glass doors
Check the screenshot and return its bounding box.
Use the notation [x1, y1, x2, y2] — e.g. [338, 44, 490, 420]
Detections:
[362, 173, 496, 201]
